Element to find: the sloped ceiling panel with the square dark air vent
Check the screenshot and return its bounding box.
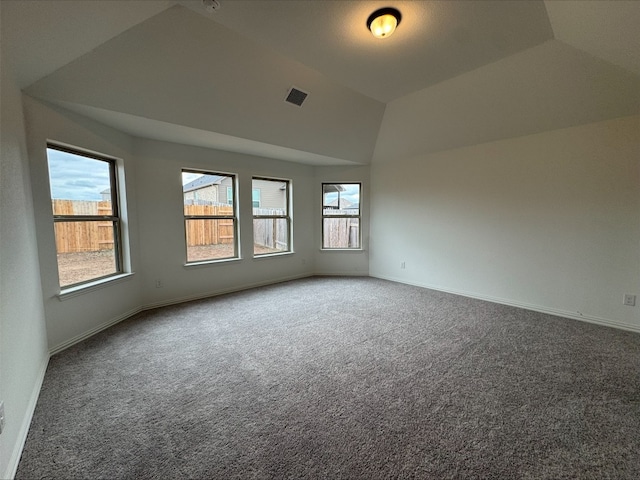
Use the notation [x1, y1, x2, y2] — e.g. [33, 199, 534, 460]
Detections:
[26, 5, 384, 167]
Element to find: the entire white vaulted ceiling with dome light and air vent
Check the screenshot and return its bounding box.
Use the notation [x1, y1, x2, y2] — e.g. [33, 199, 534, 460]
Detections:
[1, 0, 640, 165]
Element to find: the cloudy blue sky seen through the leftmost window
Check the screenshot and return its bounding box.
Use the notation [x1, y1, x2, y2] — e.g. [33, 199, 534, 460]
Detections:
[47, 148, 111, 200]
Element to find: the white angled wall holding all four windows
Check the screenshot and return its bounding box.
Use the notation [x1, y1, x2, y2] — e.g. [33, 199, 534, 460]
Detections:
[24, 96, 368, 352]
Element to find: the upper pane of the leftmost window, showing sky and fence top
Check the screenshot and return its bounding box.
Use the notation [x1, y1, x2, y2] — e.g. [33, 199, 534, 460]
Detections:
[47, 148, 113, 215]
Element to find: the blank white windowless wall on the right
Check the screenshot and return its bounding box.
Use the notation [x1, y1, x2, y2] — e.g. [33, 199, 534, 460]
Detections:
[370, 116, 640, 331]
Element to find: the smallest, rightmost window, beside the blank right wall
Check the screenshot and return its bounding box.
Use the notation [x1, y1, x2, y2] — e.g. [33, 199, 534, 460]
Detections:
[322, 183, 362, 249]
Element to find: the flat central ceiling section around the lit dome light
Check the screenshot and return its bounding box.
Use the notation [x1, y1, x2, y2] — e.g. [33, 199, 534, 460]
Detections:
[180, 0, 553, 103]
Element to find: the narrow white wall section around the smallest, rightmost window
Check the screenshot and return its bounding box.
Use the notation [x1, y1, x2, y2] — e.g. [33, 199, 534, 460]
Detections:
[312, 166, 371, 275]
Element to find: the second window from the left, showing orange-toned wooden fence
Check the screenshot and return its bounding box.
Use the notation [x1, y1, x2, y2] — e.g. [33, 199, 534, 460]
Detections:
[182, 170, 238, 263]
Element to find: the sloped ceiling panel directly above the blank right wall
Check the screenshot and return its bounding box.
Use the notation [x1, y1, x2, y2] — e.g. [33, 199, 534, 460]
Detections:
[374, 40, 640, 162]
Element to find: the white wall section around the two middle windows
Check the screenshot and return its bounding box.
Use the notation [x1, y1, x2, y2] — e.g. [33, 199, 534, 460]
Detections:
[135, 139, 319, 306]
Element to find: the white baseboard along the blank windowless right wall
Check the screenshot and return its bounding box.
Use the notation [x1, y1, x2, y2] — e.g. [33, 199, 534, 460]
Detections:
[370, 275, 640, 333]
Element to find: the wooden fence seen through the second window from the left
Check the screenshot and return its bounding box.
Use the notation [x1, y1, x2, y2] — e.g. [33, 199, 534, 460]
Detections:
[184, 205, 234, 247]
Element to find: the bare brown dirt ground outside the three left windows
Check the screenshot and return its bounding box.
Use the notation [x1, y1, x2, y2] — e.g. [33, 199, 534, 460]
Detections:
[58, 244, 280, 287]
